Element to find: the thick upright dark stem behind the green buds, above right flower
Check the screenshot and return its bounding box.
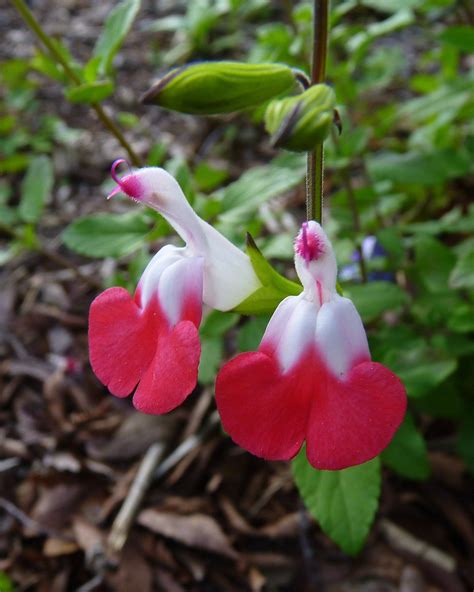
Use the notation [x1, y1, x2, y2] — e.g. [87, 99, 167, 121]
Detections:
[306, 0, 329, 223]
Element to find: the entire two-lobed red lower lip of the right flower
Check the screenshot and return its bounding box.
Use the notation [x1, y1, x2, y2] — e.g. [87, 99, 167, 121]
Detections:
[216, 349, 406, 470]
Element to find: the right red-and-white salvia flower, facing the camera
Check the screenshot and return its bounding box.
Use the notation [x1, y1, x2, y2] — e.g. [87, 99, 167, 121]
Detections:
[216, 221, 406, 470]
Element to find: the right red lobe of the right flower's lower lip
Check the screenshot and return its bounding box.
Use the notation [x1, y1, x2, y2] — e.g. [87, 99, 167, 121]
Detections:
[306, 362, 406, 470]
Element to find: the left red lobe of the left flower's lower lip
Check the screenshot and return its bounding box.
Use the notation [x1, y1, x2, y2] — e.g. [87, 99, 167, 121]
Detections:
[89, 288, 157, 397]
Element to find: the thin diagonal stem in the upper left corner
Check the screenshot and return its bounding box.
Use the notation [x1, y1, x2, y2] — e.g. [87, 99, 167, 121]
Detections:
[10, 0, 142, 166]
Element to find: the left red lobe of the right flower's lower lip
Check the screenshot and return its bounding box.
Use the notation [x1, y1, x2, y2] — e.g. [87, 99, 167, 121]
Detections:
[216, 352, 310, 460]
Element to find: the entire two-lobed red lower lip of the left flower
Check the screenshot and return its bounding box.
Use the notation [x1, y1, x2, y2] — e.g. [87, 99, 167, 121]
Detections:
[89, 288, 201, 414]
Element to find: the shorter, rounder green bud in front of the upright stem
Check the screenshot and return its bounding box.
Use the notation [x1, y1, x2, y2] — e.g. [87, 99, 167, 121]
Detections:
[265, 84, 336, 152]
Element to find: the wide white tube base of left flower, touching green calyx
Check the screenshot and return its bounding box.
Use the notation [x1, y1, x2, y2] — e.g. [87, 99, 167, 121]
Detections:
[199, 219, 261, 310]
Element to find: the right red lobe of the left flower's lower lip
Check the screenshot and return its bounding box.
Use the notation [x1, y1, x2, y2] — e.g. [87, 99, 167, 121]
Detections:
[133, 321, 201, 414]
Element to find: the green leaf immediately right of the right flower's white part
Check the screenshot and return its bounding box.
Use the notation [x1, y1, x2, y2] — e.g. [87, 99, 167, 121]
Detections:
[344, 281, 408, 323]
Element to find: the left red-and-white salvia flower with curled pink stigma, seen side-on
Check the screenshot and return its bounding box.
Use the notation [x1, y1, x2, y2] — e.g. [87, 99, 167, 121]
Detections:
[89, 160, 260, 414]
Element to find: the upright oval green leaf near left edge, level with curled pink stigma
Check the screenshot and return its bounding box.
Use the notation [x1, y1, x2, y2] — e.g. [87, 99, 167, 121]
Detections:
[18, 156, 54, 223]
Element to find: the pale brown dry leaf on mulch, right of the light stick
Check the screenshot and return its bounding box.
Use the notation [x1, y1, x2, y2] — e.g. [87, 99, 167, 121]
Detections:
[138, 509, 238, 559]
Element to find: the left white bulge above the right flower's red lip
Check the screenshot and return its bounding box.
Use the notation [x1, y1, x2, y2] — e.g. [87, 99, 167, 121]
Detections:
[259, 295, 318, 372]
